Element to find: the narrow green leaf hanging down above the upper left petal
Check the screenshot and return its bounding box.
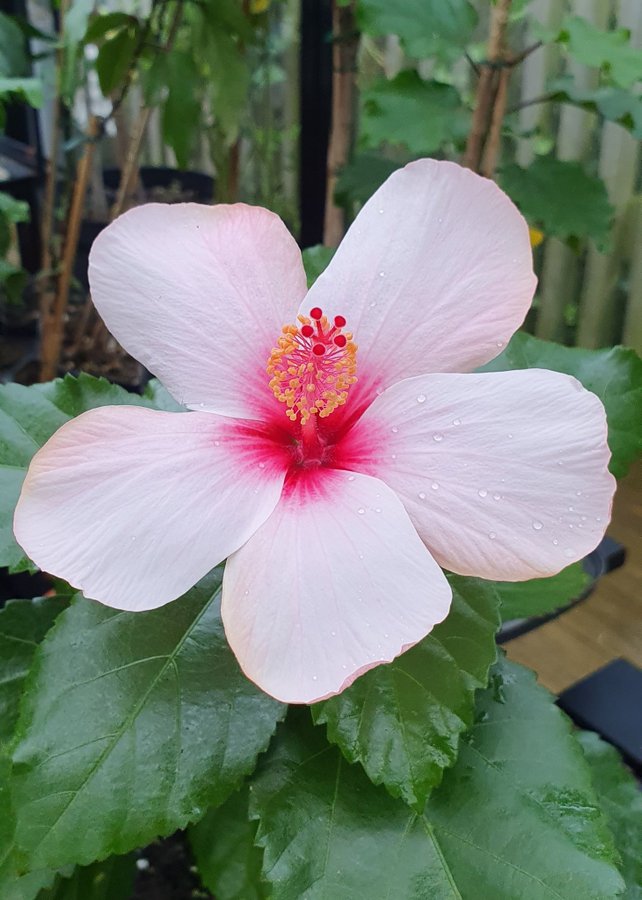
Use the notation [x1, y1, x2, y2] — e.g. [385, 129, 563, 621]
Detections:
[162, 50, 203, 169]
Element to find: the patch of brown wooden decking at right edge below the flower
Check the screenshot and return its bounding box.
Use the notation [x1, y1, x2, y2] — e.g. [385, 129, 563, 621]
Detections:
[506, 463, 642, 693]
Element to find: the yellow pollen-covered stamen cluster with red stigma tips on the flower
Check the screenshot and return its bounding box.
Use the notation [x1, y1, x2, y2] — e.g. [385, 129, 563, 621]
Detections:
[267, 306, 357, 425]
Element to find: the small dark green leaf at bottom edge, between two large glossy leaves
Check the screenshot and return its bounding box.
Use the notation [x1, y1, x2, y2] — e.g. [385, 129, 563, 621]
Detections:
[188, 785, 268, 900]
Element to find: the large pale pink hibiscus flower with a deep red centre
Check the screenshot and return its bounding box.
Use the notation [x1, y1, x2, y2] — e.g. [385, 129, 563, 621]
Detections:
[15, 160, 614, 703]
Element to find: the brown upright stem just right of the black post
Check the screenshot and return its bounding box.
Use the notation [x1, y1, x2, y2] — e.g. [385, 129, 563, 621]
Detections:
[323, 0, 359, 247]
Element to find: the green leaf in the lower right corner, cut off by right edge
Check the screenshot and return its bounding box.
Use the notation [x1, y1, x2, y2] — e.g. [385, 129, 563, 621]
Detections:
[577, 731, 642, 900]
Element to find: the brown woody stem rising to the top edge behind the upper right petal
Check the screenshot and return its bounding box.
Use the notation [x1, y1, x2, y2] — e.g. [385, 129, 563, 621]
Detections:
[462, 0, 512, 171]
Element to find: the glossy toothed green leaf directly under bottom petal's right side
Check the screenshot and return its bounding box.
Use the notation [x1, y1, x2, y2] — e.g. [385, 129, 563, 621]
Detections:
[312, 576, 499, 811]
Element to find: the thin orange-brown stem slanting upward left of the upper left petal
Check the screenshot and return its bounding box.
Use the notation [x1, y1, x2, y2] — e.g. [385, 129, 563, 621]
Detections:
[40, 116, 98, 381]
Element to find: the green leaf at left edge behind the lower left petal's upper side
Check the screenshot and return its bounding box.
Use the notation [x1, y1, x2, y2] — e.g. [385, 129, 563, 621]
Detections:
[0, 374, 155, 572]
